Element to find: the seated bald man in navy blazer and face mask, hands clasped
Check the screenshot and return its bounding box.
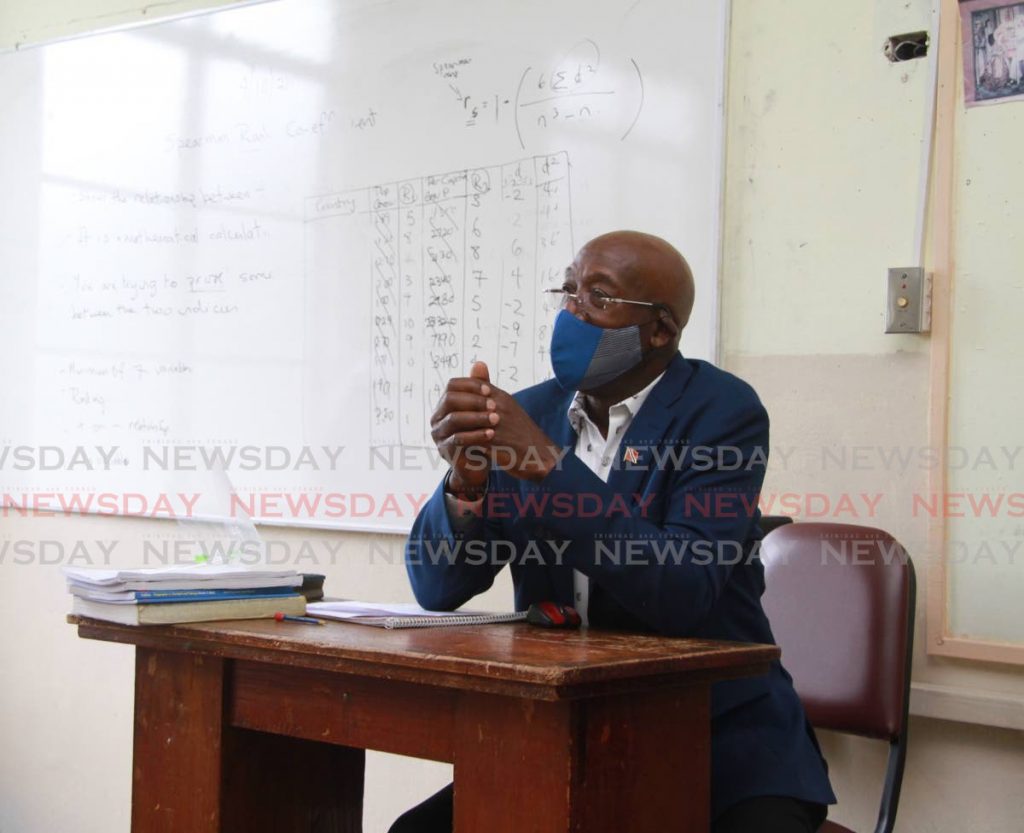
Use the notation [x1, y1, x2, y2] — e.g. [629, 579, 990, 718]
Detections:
[391, 232, 836, 833]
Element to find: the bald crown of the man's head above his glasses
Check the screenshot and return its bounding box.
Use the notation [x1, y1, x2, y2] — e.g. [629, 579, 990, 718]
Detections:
[575, 232, 694, 330]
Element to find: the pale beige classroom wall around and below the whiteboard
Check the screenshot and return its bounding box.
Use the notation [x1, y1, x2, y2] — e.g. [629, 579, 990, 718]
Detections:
[0, 0, 1024, 833]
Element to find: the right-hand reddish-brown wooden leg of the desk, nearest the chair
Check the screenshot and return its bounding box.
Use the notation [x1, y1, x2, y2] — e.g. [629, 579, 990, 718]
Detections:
[455, 685, 711, 833]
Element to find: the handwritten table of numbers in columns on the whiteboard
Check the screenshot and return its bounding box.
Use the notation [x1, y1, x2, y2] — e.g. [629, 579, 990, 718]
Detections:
[306, 153, 574, 447]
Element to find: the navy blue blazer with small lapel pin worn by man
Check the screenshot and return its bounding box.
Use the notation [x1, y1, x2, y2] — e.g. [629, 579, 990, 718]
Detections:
[406, 355, 836, 818]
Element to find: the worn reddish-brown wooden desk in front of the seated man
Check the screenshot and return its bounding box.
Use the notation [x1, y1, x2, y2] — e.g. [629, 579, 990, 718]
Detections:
[70, 617, 778, 833]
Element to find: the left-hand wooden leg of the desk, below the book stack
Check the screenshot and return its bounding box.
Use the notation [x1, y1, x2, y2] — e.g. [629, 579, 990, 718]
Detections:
[132, 648, 364, 833]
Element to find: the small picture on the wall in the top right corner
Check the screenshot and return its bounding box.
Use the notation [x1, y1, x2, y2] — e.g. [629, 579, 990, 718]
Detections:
[959, 0, 1024, 107]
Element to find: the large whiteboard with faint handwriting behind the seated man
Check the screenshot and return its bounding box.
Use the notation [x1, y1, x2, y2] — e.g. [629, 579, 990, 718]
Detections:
[0, 0, 727, 531]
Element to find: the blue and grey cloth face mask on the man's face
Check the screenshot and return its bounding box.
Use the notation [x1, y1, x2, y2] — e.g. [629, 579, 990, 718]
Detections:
[551, 309, 643, 390]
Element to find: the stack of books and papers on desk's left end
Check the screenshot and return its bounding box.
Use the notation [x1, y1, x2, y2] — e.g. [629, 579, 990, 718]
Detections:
[63, 563, 306, 625]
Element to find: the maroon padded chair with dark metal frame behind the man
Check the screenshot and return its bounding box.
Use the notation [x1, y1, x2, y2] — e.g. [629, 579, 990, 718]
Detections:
[761, 524, 915, 833]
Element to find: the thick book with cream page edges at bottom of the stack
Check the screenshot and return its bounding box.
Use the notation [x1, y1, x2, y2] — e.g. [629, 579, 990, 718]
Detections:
[71, 593, 306, 625]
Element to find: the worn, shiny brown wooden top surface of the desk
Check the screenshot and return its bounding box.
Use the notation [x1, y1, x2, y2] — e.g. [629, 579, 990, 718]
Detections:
[68, 616, 779, 700]
